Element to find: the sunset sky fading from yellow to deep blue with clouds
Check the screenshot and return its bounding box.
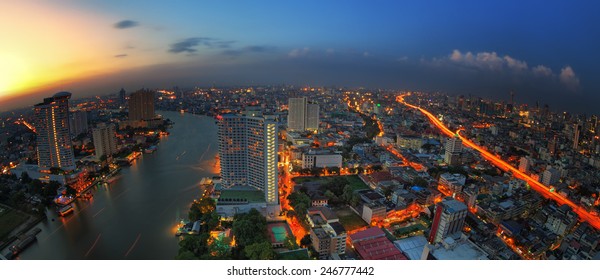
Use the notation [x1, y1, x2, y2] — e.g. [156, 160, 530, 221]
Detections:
[0, 0, 600, 114]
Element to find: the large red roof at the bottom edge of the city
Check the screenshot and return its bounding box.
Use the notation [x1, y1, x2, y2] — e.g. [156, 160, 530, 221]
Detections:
[354, 237, 407, 260]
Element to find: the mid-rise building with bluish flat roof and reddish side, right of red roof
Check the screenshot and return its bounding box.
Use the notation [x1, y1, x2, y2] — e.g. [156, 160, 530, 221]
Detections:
[428, 197, 467, 243]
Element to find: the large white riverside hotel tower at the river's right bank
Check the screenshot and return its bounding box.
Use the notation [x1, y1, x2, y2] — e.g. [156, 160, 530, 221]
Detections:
[218, 111, 279, 205]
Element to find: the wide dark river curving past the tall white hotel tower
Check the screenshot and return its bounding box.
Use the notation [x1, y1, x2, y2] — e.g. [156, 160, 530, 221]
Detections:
[20, 112, 218, 260]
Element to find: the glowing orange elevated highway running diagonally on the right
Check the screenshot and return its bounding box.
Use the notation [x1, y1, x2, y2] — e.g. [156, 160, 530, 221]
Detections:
[397, 94, 600, 229]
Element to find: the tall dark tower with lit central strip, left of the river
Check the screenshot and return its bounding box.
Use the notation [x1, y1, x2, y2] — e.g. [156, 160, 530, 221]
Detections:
[34, 92, 75, 170]
